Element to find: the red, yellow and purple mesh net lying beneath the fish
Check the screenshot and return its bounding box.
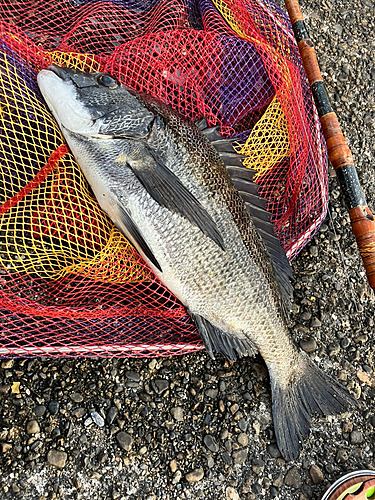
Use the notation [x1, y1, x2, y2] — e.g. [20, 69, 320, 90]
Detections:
[0, 0, 327, 356]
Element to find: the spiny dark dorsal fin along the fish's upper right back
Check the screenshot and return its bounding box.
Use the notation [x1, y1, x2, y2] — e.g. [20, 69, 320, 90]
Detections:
[199, 120, 293, 316]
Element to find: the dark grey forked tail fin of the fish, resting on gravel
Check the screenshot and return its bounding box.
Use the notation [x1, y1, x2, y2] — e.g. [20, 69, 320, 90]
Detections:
[270, 353, 357, 460]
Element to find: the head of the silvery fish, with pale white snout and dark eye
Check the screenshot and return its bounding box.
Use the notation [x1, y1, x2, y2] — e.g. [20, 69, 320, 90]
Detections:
[37, 65, 154, 139]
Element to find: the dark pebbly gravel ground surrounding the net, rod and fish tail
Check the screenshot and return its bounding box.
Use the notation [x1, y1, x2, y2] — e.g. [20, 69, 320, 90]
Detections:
[0, 0, 375, 500]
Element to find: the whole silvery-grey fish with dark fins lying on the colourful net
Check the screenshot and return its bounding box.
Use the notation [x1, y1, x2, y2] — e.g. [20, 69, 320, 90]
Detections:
[37, 65, 356, 461]
